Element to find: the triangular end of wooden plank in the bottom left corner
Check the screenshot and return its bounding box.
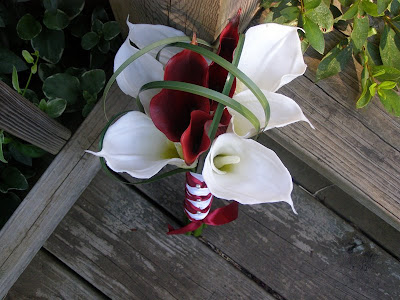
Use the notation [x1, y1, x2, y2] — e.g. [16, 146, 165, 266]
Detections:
[5, 250, 107, 300]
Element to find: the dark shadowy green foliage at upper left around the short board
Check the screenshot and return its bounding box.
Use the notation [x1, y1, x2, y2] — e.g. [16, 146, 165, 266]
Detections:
[0, 0, 122, 227]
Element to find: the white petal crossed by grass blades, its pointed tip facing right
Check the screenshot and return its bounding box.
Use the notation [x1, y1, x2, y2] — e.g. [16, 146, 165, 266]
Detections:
[228, 90, 314, 138]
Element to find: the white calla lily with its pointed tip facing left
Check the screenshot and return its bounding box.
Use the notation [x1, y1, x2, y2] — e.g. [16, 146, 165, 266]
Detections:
[87, 111, 188, 178]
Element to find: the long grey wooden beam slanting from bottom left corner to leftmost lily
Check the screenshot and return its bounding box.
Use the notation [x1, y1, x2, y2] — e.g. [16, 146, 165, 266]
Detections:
[0, 87, 132, 298]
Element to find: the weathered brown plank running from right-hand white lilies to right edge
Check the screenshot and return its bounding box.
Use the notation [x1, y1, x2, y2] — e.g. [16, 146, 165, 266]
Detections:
[267, 72, 400, 230]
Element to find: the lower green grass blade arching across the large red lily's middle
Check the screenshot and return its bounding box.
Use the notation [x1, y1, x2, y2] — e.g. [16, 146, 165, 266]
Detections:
[139, 81, 260, 131]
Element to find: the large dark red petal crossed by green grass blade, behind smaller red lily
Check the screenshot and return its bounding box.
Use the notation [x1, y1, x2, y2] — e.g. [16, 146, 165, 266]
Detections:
[150, 50, 210, 142]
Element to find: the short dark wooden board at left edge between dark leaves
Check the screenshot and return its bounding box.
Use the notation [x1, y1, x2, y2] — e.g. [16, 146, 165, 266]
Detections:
[0, 81, 71, 154]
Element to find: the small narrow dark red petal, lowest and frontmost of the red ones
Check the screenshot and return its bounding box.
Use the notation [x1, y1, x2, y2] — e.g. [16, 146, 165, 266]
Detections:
[181, 110, 212, 165]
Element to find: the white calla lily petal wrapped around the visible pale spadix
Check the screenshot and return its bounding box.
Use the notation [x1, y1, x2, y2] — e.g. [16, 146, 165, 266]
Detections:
[203, 133, 294, 210]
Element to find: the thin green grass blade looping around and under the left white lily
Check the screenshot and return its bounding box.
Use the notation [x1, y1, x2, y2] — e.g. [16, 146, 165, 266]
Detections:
[99, 110, 193, 185]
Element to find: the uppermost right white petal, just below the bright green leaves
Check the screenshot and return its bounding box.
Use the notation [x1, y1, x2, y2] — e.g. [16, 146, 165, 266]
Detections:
[238, 23, 307, 92]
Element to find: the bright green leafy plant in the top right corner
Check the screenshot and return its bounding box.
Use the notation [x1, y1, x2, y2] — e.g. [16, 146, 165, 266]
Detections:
[262, 0, 400, 116]
